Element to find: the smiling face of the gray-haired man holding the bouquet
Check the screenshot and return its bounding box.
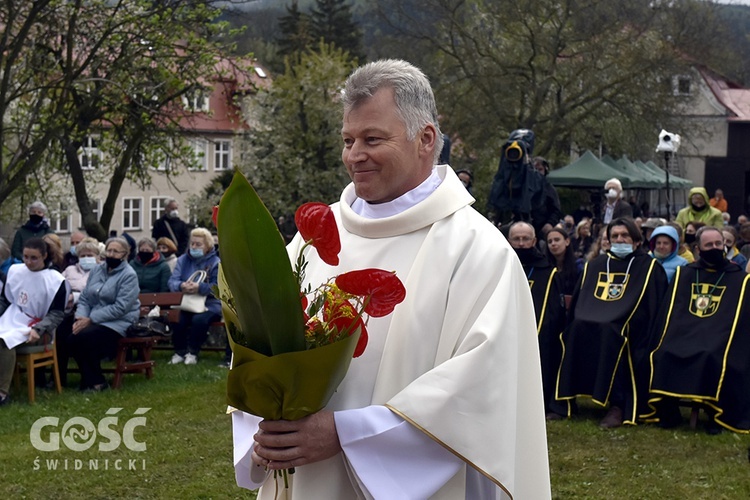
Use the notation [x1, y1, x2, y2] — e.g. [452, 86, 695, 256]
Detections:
[341, 88, 436, 203]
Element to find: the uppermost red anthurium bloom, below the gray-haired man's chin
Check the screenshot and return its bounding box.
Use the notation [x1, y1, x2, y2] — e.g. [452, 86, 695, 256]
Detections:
[294, 202, 341, 266]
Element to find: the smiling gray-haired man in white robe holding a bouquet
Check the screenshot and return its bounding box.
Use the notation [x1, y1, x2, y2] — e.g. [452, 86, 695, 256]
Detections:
[232, 60, 550, 499]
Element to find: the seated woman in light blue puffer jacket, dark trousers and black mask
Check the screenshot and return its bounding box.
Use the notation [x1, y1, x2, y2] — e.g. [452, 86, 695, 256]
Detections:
[68, 238, 140, 391]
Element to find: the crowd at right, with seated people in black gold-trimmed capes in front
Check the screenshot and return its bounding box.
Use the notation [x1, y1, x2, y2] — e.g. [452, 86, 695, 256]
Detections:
[501, 179, 750, 434]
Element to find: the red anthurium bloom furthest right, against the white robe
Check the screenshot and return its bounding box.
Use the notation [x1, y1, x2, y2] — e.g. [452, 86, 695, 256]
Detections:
[336, 269, 406, 318]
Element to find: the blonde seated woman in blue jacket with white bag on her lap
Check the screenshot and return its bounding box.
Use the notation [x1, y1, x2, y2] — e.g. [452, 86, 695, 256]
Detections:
[169, 227, 221, 365]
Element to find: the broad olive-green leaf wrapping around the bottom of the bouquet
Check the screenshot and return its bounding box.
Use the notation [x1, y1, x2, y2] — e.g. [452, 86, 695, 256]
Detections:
[227, 330, 360, 420]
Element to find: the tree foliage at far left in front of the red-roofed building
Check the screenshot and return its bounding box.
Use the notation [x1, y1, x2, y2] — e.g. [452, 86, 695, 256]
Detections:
[0, 0, 253, 239]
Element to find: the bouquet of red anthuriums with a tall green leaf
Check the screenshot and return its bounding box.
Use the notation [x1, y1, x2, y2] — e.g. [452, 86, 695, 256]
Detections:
[214, 172, 406, 420]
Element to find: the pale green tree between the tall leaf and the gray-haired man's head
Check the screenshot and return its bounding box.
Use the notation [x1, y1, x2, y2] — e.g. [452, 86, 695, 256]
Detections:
[240, 43, 354, 217]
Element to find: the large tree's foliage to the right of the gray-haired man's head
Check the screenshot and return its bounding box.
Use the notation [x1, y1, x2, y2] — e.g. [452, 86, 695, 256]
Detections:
[378, 0, 736, 212]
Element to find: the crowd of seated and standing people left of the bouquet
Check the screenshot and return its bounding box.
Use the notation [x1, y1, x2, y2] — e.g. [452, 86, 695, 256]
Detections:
[0, 200, 226, 405]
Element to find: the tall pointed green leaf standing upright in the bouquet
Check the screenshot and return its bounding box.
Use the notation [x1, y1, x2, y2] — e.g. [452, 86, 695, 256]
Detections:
[218, 171, 305, 356]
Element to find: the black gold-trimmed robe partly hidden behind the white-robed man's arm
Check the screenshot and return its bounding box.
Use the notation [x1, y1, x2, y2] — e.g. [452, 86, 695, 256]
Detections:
[521, 251, 565, 413]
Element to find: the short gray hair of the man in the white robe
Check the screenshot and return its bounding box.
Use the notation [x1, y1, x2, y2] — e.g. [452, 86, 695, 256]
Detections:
[343, 59, 443, 163]
